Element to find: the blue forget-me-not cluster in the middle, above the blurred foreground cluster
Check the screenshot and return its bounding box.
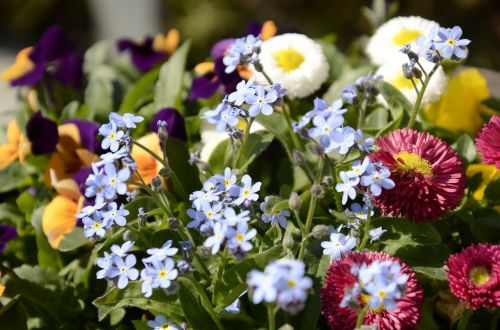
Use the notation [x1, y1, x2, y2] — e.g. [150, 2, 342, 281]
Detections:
[187, 167, 261, 259]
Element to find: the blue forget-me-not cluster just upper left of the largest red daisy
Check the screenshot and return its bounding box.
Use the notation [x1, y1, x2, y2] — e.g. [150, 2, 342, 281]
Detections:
[293, 98, 373, 155]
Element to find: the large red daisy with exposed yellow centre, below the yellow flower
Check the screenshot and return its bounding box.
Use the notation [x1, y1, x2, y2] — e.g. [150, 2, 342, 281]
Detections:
[370, 128, 466, 222]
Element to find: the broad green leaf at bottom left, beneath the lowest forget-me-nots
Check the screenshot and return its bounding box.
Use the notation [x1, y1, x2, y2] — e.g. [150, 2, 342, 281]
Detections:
[92, 281, 184, 322]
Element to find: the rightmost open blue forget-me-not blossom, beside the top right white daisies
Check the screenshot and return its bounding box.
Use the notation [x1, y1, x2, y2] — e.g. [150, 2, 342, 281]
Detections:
[435, 26, 471, 61]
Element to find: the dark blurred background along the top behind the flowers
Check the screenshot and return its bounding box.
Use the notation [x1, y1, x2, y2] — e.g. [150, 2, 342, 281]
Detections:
[0, 0, 500, 121]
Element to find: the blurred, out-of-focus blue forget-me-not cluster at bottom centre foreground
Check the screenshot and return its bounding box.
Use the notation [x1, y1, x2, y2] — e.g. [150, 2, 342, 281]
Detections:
[247, 259, 312, 314]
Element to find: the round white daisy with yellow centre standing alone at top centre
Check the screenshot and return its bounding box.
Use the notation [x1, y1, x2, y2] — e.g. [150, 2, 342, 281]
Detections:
[252, 33, 329, 98]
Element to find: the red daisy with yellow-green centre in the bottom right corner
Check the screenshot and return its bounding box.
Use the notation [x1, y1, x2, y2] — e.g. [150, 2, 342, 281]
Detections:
[446, 244, 500, 309]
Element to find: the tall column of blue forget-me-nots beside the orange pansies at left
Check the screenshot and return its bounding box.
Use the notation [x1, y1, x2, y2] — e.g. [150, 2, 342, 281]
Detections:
[77, 113, 144, 239]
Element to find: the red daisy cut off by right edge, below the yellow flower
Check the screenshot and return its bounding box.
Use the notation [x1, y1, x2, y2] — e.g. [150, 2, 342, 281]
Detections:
[476, 116, 500, 168]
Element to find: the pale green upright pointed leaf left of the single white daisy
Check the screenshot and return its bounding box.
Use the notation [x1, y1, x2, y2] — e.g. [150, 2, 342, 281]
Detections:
[154, 40, 191, 110]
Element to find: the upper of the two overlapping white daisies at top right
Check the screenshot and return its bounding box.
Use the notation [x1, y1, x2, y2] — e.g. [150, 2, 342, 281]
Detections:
[366, 16, 439, 65]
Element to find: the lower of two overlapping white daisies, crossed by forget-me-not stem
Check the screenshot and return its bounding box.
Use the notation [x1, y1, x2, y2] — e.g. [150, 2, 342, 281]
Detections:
[375, 53, 448, 105]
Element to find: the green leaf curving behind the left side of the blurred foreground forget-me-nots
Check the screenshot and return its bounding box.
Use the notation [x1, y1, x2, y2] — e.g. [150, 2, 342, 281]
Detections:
[214, 246, 285, 311]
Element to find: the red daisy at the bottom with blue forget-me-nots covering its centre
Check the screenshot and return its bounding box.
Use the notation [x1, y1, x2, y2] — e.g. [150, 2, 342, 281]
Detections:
[321, 252, 424, 330]
